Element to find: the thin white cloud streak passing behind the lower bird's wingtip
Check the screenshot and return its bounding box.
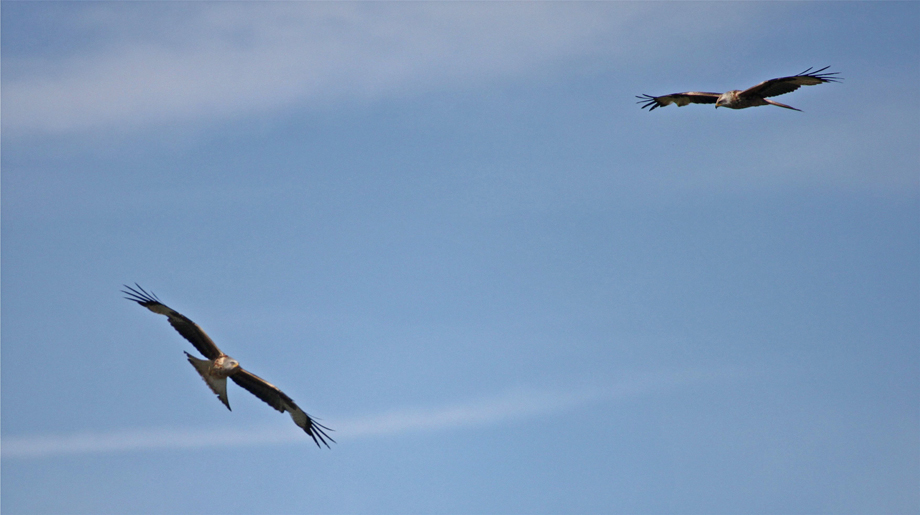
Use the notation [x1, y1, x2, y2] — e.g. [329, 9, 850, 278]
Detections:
[0, 369, 739, 459]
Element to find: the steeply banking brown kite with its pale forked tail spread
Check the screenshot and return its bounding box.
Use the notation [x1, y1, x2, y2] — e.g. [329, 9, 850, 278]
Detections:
[122, 283, 335, 448]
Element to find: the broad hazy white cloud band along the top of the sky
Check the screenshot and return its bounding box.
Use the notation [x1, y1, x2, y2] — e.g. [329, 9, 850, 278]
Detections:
[3, 2, 760, 134]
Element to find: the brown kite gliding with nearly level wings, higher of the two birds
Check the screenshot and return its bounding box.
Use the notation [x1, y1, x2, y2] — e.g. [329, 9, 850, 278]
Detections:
[636, 66, 843, 111]
